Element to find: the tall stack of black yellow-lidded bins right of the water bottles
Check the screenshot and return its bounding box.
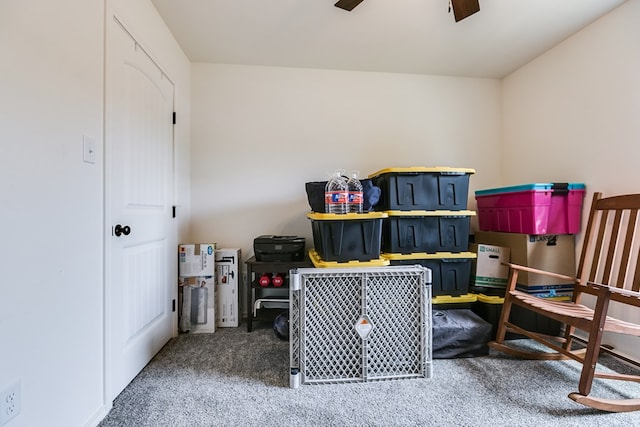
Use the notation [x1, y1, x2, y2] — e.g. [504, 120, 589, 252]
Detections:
[369, 167, 475, 308]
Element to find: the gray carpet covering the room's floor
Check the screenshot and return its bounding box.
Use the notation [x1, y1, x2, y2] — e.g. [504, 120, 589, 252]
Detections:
[100, 326, 640, 427]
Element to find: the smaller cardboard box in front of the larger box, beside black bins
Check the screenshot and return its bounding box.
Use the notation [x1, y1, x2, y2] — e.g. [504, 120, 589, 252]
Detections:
[469, 243, 511, 289]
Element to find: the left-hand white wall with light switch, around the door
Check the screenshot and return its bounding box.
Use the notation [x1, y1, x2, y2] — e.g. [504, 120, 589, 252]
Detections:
[0, 0, 190, 427]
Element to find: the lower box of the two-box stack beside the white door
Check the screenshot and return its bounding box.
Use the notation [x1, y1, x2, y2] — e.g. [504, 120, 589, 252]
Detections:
[178, 276, 216, 333]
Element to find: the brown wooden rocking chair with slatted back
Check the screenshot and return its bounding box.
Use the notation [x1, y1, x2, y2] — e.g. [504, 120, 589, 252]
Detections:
[489, 193, 640, 412]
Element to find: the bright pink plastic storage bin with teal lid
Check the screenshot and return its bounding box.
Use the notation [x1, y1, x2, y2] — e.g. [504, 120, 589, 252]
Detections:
[475, 183, 585, 234]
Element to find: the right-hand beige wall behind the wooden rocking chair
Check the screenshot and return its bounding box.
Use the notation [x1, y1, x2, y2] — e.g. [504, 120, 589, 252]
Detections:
[502, 0, 640, 360]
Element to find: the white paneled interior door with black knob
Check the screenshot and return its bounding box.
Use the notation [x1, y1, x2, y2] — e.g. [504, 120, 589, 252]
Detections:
[105, 17, 177, 399]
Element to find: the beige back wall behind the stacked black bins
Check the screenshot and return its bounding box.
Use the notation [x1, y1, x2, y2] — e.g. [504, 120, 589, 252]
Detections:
[191, 63, 501, 259]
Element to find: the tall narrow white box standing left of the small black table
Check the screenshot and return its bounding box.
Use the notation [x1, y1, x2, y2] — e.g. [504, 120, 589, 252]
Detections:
[214, 248, 242, 328]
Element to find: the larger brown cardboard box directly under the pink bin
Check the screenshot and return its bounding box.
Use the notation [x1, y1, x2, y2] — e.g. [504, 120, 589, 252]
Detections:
[475, 231, 576, 286]
